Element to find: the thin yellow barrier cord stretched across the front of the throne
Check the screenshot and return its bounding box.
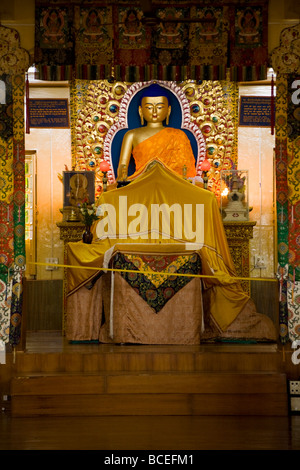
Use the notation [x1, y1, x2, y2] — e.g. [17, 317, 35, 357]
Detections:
[27, 262, 278, 282]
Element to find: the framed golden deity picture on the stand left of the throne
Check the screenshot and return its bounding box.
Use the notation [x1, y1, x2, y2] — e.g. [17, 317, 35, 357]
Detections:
[63, 171, 95, 207]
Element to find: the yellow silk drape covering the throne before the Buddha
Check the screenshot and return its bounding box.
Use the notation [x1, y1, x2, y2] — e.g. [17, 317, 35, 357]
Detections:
[68, 164, 249, 331]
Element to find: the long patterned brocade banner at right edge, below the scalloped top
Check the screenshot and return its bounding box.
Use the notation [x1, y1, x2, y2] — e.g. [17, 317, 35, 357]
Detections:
[276, 75, 300, 343]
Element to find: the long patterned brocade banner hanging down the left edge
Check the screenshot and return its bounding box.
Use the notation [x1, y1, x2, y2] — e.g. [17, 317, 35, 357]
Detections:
[0, 76, 25, 346]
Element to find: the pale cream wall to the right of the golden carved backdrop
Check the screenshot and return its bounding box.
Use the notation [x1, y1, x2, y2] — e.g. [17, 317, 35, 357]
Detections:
[238, 85, 276, 277]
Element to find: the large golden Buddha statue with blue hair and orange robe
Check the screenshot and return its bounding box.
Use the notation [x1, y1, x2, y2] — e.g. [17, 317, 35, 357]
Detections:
[118, 84, 196, 180]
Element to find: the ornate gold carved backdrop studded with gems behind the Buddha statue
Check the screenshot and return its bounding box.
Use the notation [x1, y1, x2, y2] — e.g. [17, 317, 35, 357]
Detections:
[71, 80, 238, 196]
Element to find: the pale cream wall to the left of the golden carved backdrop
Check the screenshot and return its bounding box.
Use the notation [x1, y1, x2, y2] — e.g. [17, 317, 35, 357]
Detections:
[25, 86, 71, 280]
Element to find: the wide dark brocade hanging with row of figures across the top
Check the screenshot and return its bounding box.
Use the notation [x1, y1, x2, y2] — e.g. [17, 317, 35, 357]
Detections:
[34, 0, 268, 82]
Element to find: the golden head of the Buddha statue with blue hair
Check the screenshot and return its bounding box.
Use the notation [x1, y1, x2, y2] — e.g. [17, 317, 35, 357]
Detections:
[139, 83, 171, 125]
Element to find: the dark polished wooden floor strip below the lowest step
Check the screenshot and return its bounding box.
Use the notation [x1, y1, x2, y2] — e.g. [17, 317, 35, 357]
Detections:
[0, 416, 300, 450]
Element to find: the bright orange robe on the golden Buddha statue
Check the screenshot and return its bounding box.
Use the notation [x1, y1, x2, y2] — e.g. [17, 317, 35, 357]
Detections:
[130, 127, 196, 179]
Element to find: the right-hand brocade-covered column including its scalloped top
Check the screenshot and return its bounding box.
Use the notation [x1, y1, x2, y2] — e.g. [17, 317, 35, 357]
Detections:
[271, 23, 300, 344]
